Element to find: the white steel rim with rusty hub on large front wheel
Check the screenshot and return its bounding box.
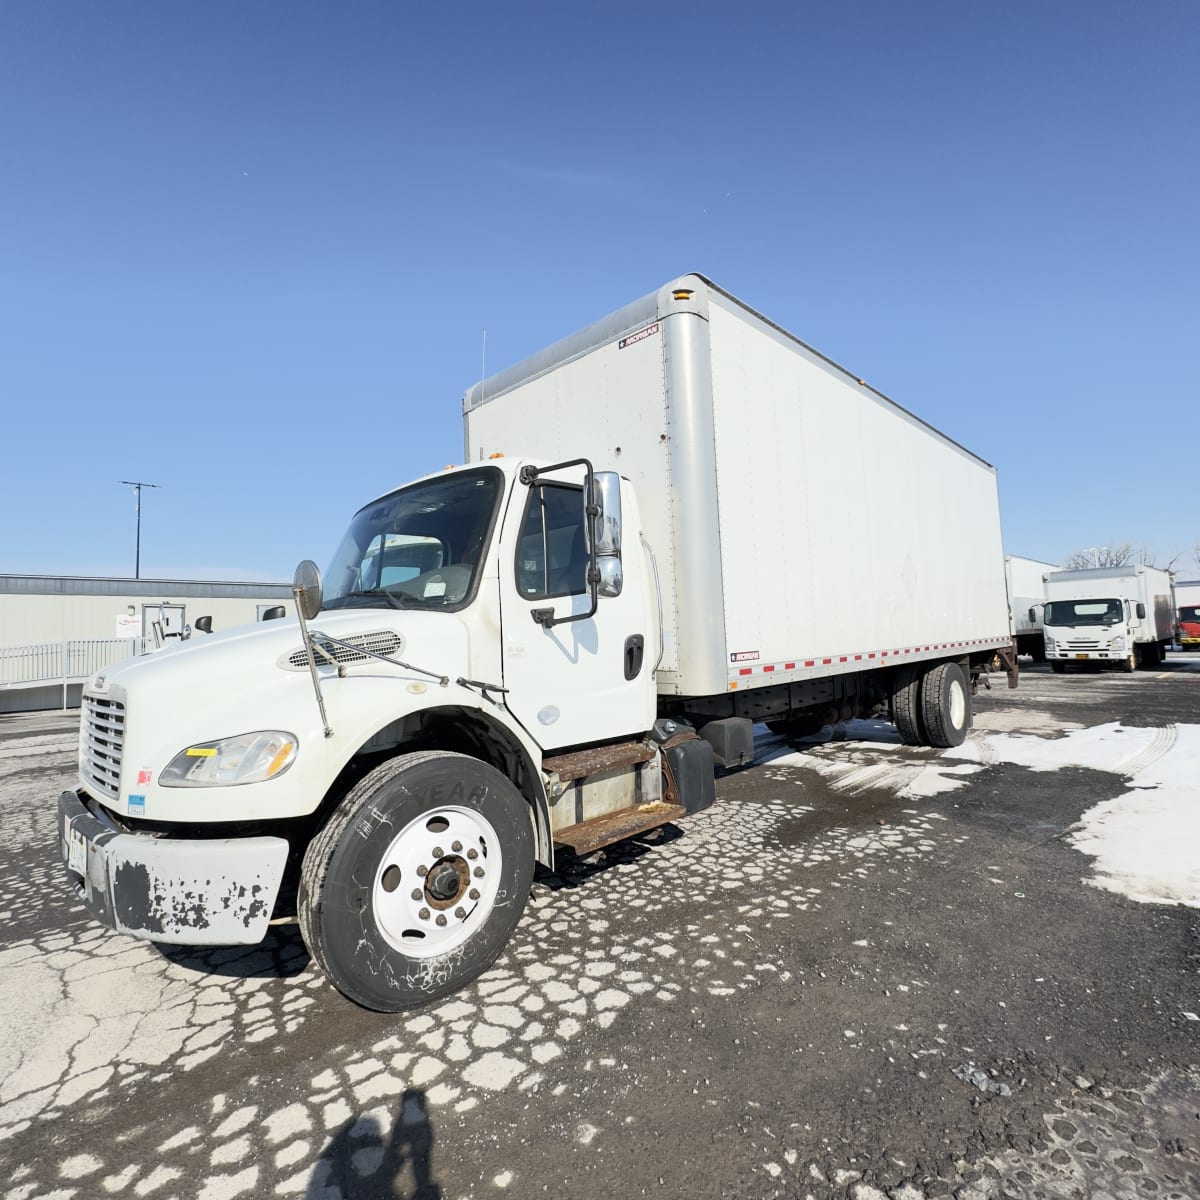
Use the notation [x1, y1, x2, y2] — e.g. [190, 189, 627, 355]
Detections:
[371, 805, 503, 959]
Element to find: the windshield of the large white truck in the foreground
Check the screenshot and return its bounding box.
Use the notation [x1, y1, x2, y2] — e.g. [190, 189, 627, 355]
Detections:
[322, 467, 504, 608]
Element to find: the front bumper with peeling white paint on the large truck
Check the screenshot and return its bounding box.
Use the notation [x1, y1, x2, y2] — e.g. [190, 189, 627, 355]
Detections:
[59, 791, 288, 946]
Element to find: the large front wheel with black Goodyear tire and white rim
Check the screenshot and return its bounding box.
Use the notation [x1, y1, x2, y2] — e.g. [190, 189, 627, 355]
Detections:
[298, 750, 534, 1013]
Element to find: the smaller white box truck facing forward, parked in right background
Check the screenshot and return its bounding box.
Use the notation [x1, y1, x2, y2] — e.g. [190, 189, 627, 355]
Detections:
[1043, 565, 1176, 674]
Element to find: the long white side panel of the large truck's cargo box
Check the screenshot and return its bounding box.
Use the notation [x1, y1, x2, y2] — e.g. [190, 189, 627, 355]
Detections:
[709, 299, 1009, 685]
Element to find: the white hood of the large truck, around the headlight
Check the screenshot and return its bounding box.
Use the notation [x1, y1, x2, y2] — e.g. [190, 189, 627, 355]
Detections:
[80, 608, 472, 821]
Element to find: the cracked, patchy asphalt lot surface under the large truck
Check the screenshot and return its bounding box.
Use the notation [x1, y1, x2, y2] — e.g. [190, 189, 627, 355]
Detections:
[0, 654, 1200, 1200]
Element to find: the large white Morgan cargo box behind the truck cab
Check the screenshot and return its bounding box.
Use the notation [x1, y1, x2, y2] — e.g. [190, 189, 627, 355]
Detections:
[463, 275, 1012, 696]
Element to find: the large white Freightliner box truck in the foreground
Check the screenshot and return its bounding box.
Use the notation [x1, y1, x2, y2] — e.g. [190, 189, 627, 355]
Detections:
[59, 276, 1015, 1010]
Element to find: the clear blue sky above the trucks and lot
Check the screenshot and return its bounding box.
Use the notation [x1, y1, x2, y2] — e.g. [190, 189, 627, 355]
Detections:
[0, 0, 1200, 580]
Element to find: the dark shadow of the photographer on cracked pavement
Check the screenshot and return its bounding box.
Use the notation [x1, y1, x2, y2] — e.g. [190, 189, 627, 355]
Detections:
[304, 1088, 443, 1200]
